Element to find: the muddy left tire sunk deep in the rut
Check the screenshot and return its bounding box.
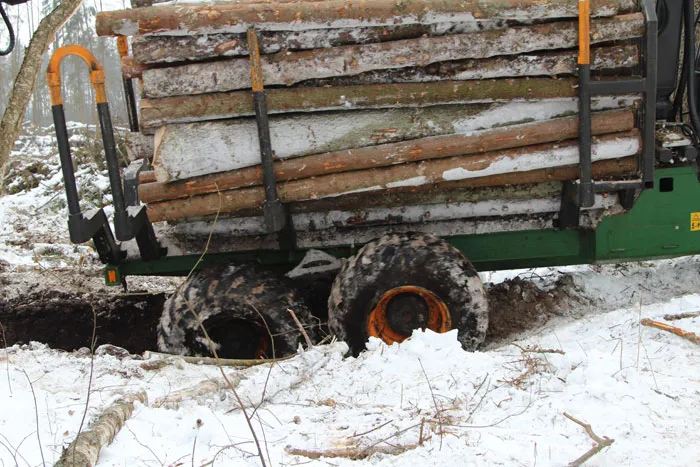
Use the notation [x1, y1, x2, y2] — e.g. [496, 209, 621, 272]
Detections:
[158, 265, 318, 358]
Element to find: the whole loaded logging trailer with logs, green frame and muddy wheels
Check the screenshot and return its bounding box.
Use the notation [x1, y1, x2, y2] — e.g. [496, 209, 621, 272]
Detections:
[47, 0, 700, 357]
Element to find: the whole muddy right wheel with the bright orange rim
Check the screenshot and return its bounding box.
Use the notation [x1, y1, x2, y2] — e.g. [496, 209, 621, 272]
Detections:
[328, 234, 488, 355]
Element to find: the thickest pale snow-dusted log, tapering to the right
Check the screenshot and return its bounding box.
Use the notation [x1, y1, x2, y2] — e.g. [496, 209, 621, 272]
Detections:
[153, 105, 489, 182]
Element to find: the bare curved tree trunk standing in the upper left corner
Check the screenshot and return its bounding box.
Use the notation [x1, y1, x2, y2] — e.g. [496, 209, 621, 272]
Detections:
[0, 0, 82, 186]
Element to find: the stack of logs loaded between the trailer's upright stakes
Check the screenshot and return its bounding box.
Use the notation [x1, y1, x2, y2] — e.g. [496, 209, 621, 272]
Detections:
[97, 0, 644, 227]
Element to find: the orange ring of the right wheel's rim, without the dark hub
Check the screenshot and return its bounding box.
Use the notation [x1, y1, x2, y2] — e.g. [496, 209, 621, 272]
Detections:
[367, 285, 452, 344]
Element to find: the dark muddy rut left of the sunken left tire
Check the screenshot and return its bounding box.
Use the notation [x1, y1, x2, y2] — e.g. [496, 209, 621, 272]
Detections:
[0, 291, 166, 353]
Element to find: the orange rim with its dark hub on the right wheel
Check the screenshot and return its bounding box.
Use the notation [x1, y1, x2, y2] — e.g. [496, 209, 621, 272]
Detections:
[367, 285, 452, 344]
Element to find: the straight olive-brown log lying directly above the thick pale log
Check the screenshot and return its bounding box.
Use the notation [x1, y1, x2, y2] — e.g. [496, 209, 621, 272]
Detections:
[141, 78, 578, 128]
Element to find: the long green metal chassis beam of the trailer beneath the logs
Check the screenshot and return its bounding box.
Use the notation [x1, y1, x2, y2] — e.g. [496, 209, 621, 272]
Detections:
[105, 164, 700, 285]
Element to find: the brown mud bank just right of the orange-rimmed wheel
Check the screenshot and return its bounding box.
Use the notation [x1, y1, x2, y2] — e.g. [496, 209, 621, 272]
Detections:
[484, 275, 583, 348]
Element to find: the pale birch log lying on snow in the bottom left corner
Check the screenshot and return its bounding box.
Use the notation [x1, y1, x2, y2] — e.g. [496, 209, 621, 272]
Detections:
[54, 391, 148, 467]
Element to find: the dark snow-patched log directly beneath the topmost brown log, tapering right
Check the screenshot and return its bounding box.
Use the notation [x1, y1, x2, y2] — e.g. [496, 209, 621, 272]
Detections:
[131, 20, 517, 65]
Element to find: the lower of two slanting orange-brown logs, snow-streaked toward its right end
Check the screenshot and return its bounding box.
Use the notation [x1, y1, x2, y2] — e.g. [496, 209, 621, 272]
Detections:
[148, 130, 641, 222]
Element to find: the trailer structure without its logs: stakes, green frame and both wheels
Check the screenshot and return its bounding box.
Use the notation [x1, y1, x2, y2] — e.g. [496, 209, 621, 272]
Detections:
[47, 0, 700, 357]
